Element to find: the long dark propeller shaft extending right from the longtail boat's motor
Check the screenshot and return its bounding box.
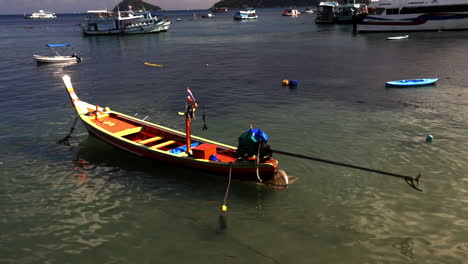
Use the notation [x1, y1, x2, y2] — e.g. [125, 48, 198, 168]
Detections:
[272, 150, 422, 192]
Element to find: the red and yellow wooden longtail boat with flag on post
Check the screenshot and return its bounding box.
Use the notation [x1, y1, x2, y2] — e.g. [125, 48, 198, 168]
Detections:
[62, 75, 289, 186]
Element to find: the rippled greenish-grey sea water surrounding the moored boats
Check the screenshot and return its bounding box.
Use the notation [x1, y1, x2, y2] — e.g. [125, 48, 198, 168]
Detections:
[0, 9, 468, 263]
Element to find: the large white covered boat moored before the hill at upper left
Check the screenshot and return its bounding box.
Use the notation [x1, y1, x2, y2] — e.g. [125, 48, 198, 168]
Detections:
[81, 10, 171, 35]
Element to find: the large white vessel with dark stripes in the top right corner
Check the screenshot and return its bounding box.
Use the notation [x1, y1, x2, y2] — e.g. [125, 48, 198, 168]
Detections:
[357, 0, 468, 32]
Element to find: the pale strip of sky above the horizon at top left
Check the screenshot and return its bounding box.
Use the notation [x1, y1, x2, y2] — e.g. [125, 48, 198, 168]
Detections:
[0, 0, 218, 15]
